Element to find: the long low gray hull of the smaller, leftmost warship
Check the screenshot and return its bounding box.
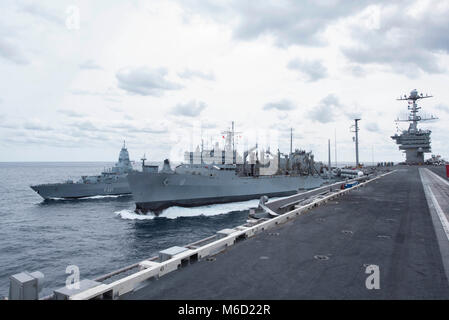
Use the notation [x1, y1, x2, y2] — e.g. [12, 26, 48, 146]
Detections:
[31, 178, 131, 200]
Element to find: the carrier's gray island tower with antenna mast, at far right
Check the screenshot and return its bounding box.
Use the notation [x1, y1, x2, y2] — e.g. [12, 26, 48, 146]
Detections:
[391, 89, 438, 164]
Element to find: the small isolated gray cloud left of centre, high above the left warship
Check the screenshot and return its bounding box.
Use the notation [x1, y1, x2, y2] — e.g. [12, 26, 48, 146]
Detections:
[116, 67, 182, 96]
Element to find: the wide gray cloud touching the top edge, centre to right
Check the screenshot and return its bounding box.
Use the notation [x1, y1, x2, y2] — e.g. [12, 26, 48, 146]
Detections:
[180, 0, 386, 47]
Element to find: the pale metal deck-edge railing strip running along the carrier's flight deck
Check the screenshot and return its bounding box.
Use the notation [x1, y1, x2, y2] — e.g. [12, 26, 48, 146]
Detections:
[40, 171, 394, 300]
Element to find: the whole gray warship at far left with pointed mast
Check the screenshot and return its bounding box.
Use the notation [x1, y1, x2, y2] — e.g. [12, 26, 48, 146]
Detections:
[31, 142, 135, 200]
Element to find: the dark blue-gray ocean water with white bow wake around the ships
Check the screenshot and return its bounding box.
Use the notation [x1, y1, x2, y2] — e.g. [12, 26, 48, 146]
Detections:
[0, 162, 258, 297]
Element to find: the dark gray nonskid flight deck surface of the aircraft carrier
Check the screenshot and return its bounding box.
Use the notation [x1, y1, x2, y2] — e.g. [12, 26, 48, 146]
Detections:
[122, 166, 449, 299]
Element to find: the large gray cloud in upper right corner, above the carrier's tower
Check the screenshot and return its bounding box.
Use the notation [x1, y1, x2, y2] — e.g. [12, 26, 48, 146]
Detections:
[342, 1, 449, 77]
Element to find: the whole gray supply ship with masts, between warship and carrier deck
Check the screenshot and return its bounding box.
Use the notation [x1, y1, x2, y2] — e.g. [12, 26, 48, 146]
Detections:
[128, 125, 325, 214]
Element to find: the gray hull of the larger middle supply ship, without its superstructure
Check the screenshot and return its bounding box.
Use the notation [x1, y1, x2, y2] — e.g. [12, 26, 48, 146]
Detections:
[128, 172, 323, 213]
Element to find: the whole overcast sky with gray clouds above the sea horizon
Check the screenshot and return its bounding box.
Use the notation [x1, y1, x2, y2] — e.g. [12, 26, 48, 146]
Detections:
[0, 0, 449, 162]
